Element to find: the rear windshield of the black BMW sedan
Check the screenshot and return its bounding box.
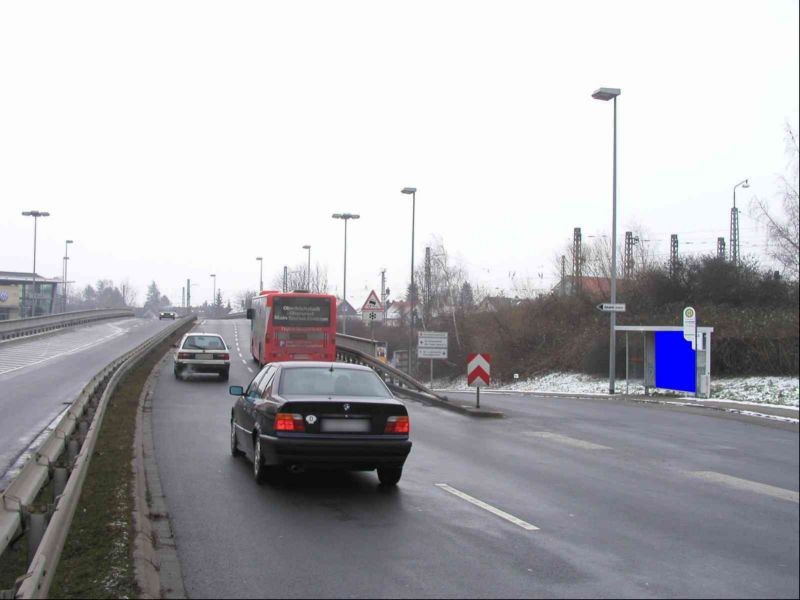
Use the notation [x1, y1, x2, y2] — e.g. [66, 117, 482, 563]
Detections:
[279, 367, 391, 398]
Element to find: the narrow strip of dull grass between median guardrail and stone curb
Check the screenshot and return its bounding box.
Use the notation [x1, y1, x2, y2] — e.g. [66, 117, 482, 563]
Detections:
[50, 329, 191, 598]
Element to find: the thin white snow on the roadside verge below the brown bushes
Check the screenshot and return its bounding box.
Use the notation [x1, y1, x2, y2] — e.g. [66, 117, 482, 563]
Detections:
[433, 373, 800, 407]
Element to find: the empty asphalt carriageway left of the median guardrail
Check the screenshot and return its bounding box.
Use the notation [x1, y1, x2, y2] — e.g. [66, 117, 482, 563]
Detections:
[0, 318, 173, 489]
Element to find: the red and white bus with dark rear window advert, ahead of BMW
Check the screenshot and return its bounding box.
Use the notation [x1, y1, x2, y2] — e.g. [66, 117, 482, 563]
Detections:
[247, 291, 336, 365]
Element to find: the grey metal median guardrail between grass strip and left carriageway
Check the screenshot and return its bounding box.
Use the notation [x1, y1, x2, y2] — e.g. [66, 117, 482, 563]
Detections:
[0, 315, 195, 598]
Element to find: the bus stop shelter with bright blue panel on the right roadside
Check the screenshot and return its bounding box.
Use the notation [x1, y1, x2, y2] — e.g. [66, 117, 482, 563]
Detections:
[614, 325, 714, 398]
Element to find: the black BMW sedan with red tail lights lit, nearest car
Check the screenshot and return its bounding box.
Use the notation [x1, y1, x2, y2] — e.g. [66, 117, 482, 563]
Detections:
[230, 361, 411, 485]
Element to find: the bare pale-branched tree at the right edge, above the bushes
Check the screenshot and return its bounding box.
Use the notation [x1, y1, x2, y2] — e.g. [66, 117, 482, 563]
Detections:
[750, 124, 800, 279]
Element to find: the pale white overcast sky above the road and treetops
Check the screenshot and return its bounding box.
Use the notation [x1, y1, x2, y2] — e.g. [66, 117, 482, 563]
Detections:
[0, 0, 800, 306]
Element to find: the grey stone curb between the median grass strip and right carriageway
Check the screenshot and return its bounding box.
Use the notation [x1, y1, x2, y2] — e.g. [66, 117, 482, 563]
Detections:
[133, 350, 186, 598]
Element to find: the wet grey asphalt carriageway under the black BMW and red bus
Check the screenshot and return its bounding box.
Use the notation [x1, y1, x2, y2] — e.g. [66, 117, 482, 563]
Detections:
[152, 321, 799, 598]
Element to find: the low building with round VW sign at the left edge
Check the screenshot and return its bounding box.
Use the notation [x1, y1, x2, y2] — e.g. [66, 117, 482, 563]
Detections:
[0, 271, 62, 321]
